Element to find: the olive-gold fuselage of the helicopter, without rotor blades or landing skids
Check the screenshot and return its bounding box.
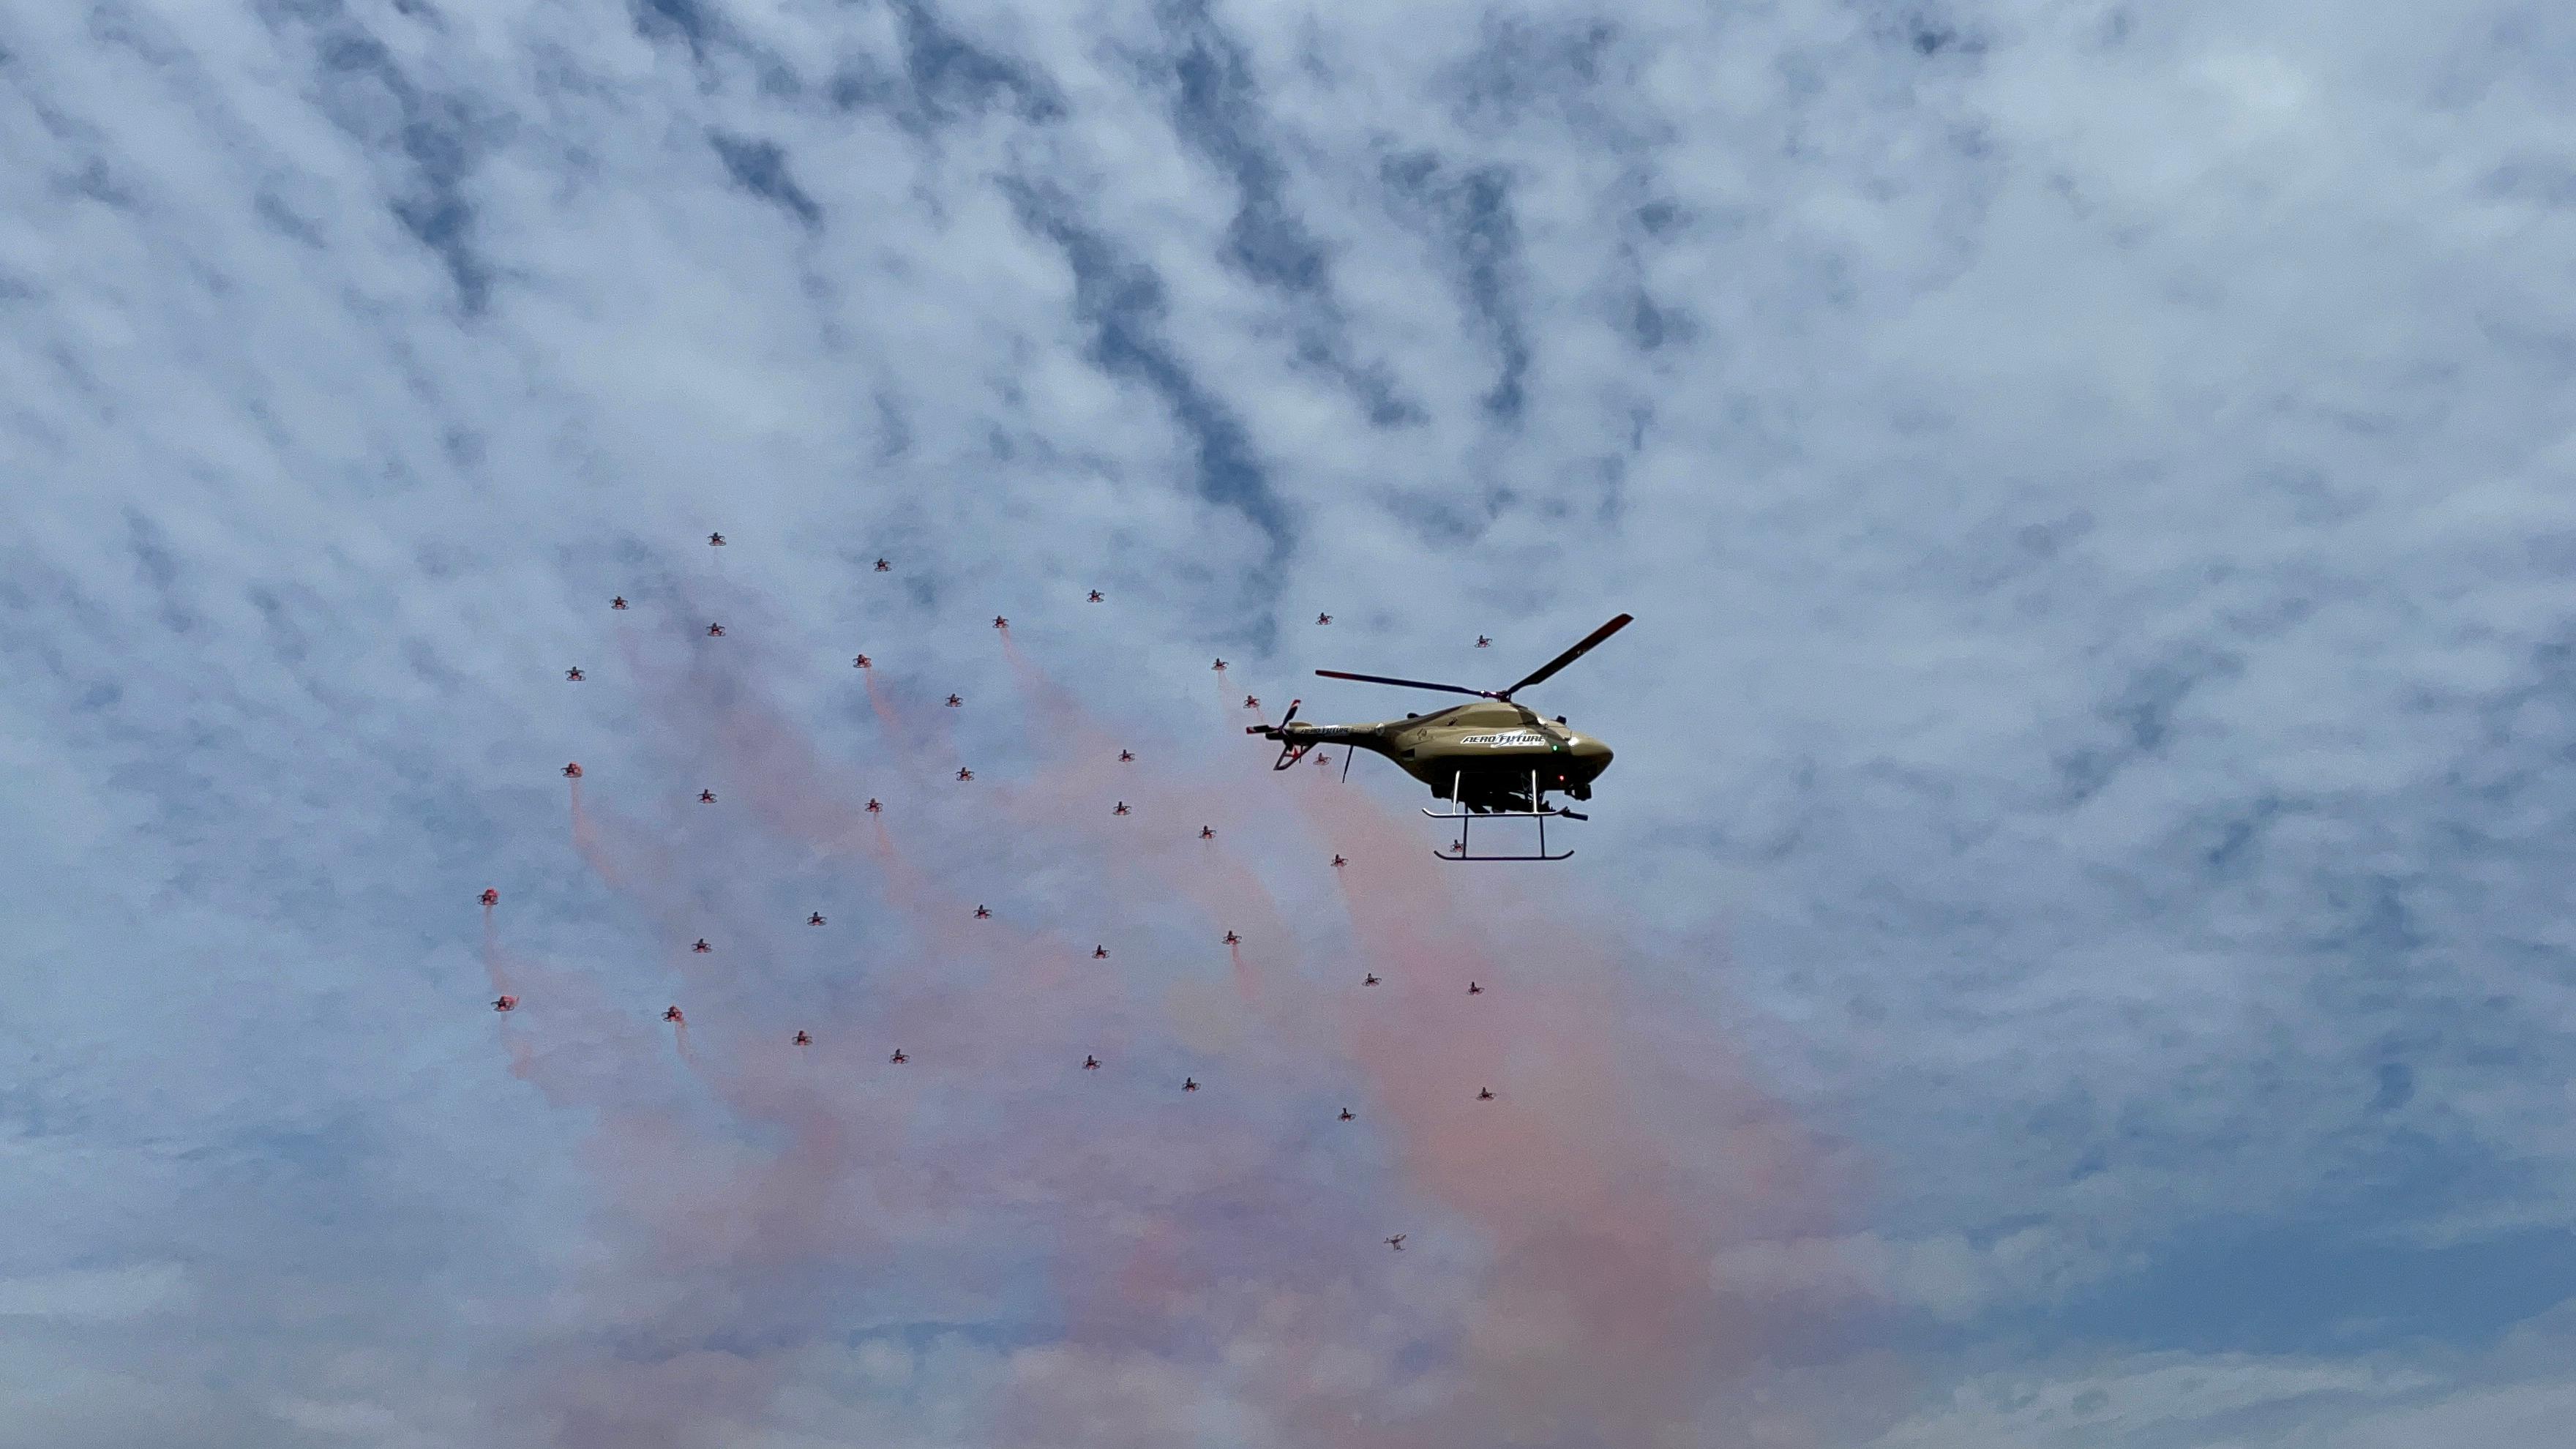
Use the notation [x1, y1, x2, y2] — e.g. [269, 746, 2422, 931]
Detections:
[1262, 701, 1610, 809]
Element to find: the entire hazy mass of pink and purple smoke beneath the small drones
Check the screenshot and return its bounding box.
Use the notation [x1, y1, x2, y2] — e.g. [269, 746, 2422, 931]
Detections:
[497, 583, 1808, 1449]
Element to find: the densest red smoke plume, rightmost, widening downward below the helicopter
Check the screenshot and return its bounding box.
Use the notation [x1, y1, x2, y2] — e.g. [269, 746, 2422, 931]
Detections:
[978, 637, 1813, 1444]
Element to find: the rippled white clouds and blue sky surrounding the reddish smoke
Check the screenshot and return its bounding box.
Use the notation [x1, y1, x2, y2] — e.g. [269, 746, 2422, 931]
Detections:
[0, 0, 2576, 1444]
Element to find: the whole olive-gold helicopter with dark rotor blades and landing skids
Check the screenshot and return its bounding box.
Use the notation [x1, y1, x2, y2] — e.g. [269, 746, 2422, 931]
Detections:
[1244, 614, 1630, 861]
